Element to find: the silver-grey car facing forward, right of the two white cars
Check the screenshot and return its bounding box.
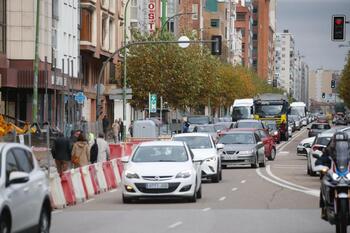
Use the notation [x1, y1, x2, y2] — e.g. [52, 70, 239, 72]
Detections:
[217, 129, 265, 168]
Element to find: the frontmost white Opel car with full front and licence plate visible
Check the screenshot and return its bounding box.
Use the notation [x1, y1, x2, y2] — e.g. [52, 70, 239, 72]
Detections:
[122, 141, 202, 203]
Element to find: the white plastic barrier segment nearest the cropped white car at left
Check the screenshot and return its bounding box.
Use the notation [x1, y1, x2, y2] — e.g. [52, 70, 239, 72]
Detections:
[50, 171, 66, 209]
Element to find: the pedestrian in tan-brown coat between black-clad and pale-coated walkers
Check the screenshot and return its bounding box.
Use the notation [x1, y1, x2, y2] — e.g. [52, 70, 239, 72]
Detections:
[71, 134, 90, 167]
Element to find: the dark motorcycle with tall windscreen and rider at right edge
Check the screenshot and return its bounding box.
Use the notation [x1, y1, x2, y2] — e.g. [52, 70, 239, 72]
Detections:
[320, 133, 350, 233]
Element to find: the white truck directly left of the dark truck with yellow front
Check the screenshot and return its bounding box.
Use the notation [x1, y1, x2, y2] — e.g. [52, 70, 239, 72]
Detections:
[231, 99, 254, 122]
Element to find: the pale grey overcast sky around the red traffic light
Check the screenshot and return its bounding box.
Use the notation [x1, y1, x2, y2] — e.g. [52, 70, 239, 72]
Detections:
[276, 0, 350, 70]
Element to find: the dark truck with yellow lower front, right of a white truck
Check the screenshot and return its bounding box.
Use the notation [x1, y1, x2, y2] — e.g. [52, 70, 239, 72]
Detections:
[254, 93, 289, 141]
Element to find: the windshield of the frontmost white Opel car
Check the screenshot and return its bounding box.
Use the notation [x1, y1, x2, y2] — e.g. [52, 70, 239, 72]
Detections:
[132, 146, 188, 163]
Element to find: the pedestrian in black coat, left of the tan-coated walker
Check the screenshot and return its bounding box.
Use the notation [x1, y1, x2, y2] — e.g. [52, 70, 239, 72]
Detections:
[51, 132, 71, 175]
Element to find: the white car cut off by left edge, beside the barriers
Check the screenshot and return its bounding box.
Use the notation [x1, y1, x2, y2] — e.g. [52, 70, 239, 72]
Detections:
[0, 143, 51, 233]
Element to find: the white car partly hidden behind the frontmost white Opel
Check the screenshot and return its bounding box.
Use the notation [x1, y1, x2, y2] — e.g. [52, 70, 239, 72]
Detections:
[172, 133, 222, 183]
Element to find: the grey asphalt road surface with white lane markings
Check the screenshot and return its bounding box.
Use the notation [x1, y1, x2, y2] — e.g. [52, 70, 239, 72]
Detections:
[51, 129, 335, 233]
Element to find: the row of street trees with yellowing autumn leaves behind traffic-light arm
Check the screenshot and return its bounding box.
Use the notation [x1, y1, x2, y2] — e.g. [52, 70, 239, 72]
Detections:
[127, 33, 282, 114]
